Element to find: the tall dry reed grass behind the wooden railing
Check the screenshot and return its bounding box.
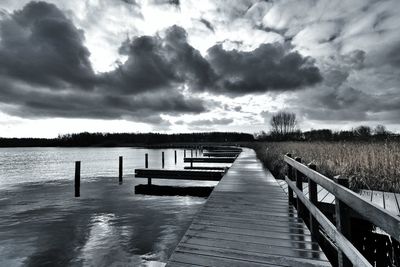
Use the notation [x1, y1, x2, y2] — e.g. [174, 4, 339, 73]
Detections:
[252, 142, 400, 193]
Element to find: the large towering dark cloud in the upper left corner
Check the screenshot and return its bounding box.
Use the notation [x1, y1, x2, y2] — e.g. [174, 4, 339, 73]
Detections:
[0, 2, 95, 89]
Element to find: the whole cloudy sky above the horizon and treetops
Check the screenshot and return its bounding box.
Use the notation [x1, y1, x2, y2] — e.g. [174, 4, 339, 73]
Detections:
[0, 0, 400, 137]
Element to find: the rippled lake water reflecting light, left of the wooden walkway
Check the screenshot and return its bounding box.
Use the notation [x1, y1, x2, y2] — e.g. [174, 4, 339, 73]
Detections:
[0, 148, 222, 266]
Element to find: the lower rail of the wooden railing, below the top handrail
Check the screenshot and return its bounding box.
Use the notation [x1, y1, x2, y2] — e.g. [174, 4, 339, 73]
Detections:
[285, 177, 372, 267]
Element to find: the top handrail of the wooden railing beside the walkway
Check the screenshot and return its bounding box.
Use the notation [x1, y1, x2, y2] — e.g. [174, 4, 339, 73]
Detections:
[284, 155, 400, 242]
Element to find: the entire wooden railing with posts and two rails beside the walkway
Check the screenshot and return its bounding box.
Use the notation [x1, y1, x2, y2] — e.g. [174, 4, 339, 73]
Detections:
[284, 154, 400, 266]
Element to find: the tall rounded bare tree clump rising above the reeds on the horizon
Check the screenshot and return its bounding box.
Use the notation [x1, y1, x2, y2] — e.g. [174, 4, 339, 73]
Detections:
[270, 111, 297, 137]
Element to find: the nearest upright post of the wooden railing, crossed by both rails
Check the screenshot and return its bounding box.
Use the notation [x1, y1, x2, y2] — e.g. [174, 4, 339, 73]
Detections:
[333, 175, 353, 267]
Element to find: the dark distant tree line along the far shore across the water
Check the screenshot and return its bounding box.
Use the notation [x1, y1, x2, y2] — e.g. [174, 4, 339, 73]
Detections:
[0, 132, 254, 147]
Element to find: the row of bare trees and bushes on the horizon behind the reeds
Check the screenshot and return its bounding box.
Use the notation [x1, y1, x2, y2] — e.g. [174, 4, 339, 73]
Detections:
[255, 112, 400, 141]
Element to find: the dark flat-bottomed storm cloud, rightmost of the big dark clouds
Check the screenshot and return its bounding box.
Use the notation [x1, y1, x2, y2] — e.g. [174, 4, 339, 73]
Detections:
[208, 43, 322, 95]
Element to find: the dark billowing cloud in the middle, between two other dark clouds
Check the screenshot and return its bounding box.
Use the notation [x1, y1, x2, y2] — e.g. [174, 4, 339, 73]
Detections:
[102, 26, 215, 94]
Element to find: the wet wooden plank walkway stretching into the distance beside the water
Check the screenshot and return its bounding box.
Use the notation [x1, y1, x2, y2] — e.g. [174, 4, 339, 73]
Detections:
[167, 149, 331, 267]
